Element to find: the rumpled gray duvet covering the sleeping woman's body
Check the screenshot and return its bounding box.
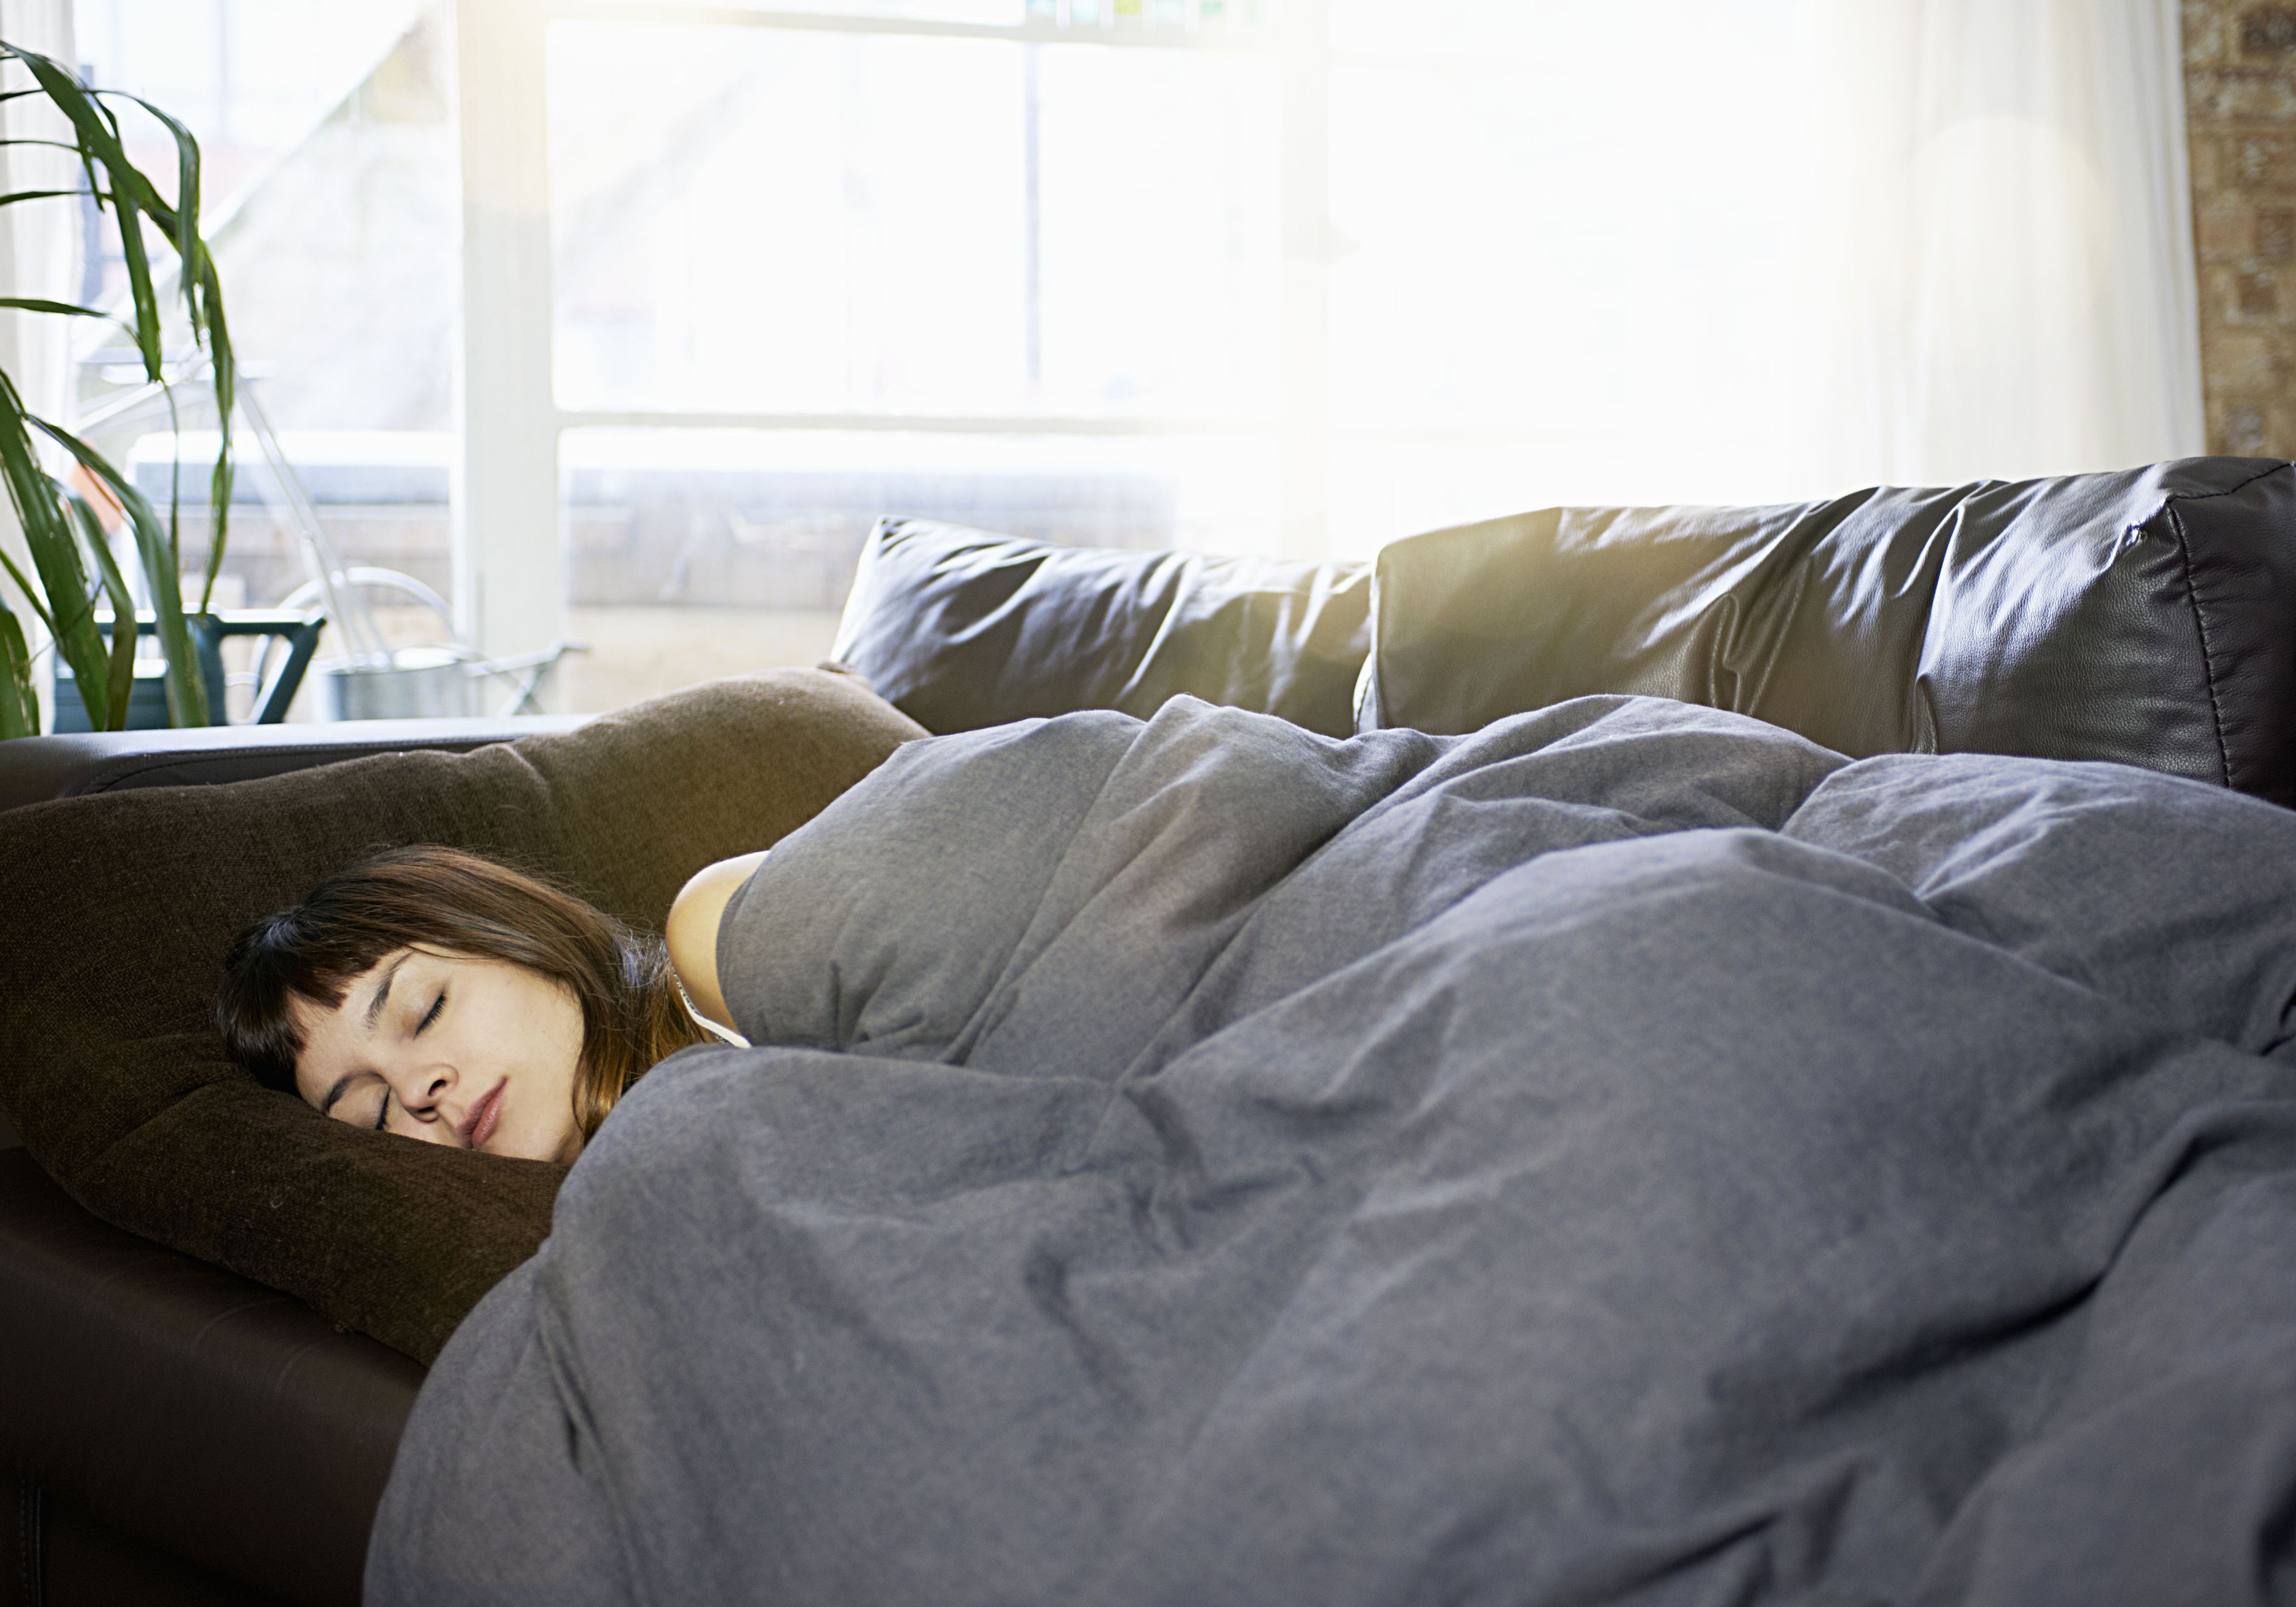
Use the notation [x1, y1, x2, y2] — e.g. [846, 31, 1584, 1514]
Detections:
[368, 698, 2296, 1607]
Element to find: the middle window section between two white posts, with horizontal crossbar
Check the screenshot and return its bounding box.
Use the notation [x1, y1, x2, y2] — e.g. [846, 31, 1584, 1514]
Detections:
[530, 5, 1284, 700]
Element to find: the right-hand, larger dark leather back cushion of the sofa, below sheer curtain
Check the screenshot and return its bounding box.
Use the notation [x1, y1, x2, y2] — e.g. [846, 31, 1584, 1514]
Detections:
[1357, 457, 2296, 804]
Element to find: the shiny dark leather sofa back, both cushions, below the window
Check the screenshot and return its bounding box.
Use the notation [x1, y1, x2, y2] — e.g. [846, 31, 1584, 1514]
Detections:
[836, 457, 2296, 804]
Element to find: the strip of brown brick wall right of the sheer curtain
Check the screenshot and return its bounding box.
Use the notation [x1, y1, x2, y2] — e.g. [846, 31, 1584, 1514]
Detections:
[2183, 0, 2296, 457]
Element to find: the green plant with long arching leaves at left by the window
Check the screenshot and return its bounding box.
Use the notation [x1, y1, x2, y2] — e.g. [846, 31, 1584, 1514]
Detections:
[0, 41, 239, 739]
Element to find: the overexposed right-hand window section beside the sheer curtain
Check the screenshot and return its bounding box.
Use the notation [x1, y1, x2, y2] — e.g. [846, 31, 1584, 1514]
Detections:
[1327, 0, 1830, 539]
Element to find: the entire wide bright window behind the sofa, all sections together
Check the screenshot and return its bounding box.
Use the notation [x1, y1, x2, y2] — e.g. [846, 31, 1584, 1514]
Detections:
[78, 0, 1802, 707]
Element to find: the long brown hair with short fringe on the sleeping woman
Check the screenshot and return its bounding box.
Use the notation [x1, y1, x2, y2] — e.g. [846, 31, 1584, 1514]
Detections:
[216, 845, 707, 1139]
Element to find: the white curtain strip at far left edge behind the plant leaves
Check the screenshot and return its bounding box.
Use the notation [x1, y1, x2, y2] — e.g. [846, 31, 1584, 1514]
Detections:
[0, 0, 85, 721]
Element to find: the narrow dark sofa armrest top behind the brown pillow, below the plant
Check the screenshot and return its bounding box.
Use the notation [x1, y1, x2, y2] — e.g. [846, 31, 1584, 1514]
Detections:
[0, 714, 583, 810]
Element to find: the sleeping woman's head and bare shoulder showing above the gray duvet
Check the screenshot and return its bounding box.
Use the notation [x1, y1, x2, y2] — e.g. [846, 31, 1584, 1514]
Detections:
[216, 847, 765, 1161]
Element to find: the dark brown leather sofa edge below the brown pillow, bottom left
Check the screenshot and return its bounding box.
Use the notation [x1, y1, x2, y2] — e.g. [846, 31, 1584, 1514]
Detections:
[0, 1150, 422, 1607]
